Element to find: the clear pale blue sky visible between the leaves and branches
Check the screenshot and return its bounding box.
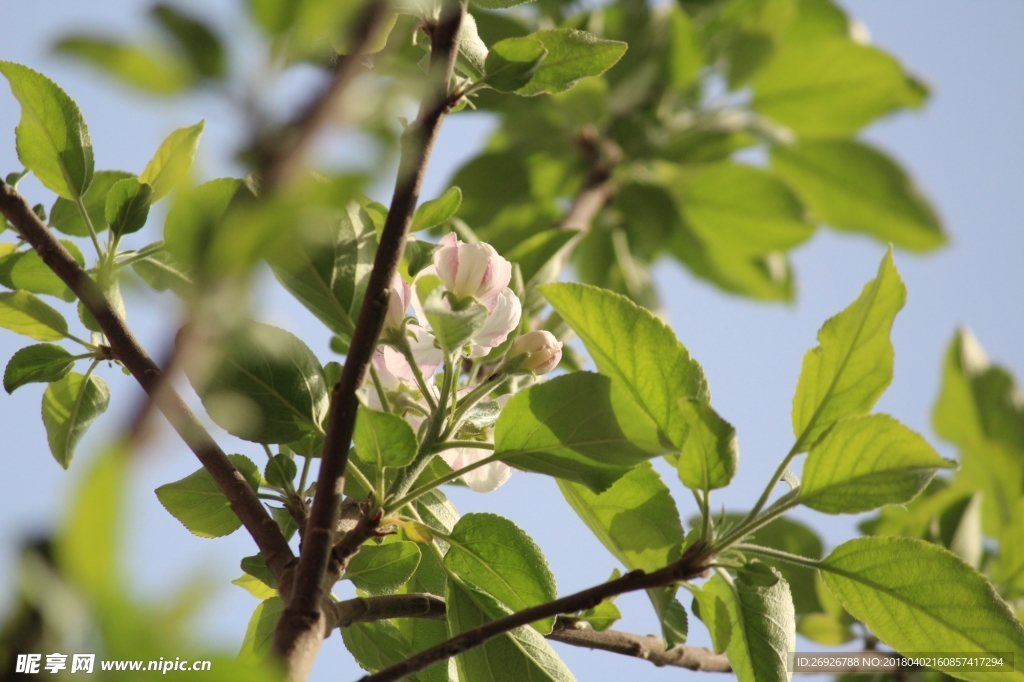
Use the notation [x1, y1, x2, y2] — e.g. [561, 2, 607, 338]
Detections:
[0, 0, 1024, 682]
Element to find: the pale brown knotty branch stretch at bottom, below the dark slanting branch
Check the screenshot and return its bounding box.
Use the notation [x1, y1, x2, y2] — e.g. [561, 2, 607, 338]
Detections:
[547, 617, 732, 673]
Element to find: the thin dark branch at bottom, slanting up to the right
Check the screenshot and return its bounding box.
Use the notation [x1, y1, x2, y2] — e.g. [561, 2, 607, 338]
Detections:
[359, 545, 709, 682]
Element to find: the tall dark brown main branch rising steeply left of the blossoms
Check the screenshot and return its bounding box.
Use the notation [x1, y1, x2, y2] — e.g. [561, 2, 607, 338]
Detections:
[274, 0, 466, 679]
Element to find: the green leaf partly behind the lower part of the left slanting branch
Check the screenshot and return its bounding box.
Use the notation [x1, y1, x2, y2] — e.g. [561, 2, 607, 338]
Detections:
[156, 455, 259, 536]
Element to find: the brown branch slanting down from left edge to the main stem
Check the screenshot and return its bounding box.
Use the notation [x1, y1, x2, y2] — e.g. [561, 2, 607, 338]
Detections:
[0, 182, 295, 583]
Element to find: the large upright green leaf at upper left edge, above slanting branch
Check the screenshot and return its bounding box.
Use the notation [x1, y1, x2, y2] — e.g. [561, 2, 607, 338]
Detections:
[0, 61, 93, 199]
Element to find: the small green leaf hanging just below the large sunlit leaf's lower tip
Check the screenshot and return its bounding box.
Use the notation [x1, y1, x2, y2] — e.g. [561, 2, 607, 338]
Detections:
[677, 398, 739, 492]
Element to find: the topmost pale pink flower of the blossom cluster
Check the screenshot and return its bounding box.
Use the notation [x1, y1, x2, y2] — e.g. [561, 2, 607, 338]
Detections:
[434, 232, 512, 310]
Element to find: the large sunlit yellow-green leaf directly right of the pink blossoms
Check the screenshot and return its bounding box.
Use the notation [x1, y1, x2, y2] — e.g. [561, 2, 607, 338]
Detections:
[541, 284, 710, 449]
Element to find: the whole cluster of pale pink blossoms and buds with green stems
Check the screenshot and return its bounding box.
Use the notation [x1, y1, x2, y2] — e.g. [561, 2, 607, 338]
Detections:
[366, 233, 561, 493]
